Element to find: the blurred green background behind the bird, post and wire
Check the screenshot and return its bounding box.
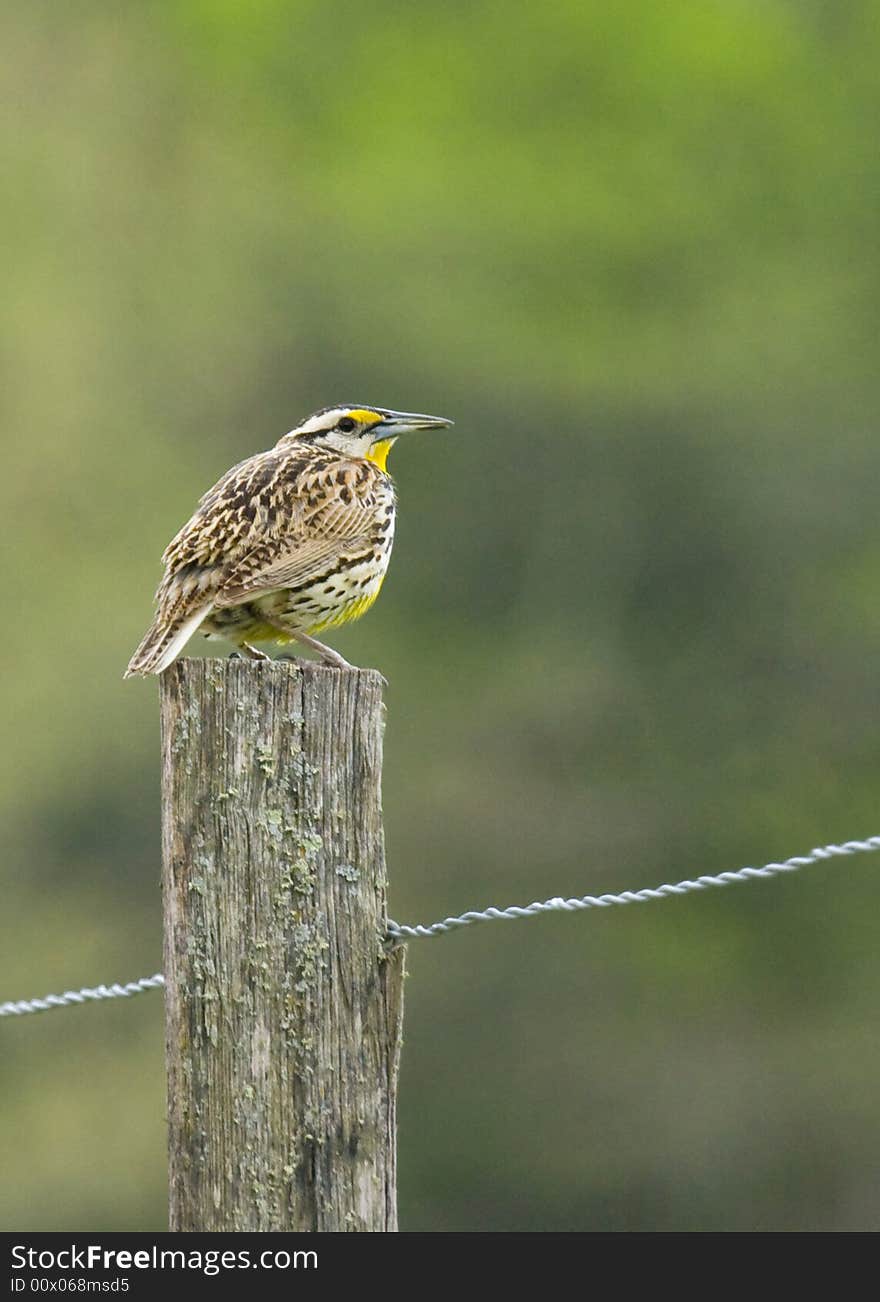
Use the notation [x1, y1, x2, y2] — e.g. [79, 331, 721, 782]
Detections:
[0, 0, 880, 1230]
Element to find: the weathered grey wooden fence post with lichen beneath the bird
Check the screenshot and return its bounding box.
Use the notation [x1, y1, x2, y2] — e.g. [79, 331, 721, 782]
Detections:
[160, 659, 404, 1230]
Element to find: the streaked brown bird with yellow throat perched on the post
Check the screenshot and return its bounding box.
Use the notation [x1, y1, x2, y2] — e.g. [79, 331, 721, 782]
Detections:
[125, 404, 453, 678]
